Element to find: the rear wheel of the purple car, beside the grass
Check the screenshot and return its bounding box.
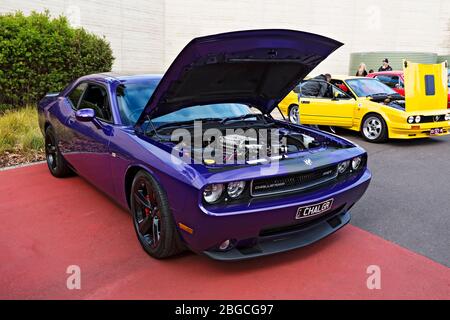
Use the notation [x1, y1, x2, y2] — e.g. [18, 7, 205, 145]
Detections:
[45, 126, 73, 178]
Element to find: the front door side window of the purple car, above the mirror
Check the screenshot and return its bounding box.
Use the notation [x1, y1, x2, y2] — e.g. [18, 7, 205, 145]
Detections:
[78, 84, 112, 122]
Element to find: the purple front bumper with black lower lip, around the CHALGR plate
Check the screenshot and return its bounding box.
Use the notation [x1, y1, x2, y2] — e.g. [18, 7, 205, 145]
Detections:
[176, 169, 371, 260]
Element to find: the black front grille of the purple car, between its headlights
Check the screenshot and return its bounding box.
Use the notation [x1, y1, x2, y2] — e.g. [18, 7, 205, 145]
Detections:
[250, 166, 337, 197]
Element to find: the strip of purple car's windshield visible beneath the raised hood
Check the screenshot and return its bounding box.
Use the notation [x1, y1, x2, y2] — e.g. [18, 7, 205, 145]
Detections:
[152, 103, 252, 127]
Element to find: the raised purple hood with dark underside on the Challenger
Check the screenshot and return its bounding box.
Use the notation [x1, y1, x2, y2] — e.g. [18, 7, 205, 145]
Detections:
[136, 30, 342, 126]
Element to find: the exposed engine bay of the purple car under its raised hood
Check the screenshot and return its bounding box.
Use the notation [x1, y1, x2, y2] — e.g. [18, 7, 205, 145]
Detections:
[151, 118, 347, 165]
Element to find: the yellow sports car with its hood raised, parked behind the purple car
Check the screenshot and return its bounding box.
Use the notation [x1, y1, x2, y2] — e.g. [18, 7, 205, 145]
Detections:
[280, 61, 450, 142]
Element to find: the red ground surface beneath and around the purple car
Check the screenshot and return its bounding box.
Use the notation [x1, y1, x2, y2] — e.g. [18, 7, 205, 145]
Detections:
[0, 164, 450, 299]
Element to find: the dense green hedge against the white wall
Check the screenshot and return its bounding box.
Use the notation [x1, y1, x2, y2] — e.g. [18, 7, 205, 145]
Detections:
[0, 12, 114, 106]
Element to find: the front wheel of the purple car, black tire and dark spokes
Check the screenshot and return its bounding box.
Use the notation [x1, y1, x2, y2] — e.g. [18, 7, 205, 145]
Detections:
[130, 170, 185, 259]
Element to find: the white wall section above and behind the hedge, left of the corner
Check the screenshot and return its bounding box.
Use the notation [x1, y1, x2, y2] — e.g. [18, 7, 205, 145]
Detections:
[0, 0, 164, 72]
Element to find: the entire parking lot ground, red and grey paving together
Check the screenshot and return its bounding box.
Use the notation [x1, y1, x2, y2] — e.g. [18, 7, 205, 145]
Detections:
[0, 131, 450, 299]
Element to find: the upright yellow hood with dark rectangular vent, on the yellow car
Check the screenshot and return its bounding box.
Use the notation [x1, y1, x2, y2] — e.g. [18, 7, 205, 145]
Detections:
[403, 61, 448, 112]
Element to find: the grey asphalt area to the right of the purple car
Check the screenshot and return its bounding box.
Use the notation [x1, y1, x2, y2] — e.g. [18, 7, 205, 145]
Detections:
[337, 129, 450, 267]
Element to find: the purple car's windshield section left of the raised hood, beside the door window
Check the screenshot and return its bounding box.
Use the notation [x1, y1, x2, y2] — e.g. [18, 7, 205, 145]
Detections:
[117, 79, 159, 125]
